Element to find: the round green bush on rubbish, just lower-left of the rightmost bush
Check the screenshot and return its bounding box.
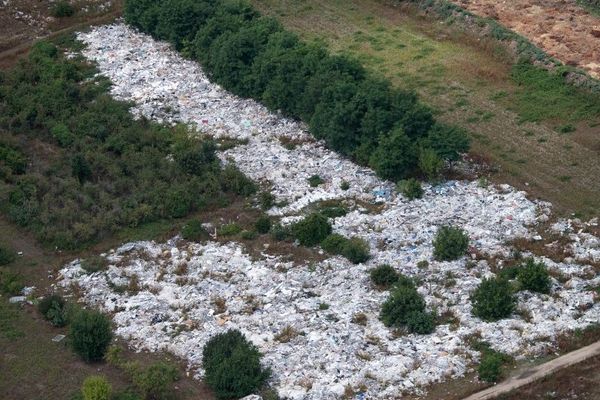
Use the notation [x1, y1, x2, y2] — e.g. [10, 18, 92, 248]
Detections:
[471, 278, 516, 321]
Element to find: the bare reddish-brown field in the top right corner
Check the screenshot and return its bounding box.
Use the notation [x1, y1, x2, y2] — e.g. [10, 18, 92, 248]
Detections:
[451, 0, 600, 78]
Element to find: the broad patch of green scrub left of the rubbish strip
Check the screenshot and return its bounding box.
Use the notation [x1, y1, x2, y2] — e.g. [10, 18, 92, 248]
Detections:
[0, 39, 254, 249]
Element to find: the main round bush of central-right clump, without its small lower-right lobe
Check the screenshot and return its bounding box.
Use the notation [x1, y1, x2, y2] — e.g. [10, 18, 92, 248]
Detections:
[379, 286, 425, 327]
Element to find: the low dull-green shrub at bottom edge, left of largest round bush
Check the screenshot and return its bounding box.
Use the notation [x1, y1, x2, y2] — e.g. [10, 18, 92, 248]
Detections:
[131, 361, 179, 400]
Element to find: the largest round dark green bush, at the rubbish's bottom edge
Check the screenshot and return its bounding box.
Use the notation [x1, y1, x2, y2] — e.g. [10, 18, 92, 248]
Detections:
[202, 330, 271, 399]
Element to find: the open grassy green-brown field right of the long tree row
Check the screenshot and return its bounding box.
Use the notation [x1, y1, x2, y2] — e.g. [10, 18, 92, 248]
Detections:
[253, 0, 600, 216]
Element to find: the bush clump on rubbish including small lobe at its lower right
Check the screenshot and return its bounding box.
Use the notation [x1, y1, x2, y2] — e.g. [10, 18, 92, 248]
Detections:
[379, 281, 436, 334]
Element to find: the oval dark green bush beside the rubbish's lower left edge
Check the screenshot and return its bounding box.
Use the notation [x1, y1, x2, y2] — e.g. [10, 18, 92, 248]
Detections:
[69, 310, 112, 362]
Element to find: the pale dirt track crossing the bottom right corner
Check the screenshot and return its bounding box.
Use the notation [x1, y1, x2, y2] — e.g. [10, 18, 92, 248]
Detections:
[464, 342, 600, 400]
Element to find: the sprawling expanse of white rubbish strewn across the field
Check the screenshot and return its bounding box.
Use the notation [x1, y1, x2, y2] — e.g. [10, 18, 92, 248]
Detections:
[59, 24, 600, 399]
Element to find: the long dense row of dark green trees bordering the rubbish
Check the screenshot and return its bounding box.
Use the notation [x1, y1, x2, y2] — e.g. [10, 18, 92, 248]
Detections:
[125, 0, 469, 181]
